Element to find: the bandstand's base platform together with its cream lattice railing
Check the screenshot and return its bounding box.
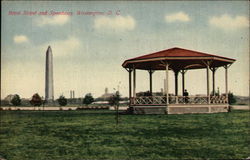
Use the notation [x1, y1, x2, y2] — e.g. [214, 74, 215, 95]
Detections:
[130, 96, 229, 114]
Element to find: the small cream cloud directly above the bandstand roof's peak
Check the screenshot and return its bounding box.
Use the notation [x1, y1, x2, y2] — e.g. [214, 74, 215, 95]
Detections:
[165, 12, 190, 23]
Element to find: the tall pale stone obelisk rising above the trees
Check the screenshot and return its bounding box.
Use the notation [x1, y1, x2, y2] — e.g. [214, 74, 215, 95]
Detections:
[45, 46, 54, 102]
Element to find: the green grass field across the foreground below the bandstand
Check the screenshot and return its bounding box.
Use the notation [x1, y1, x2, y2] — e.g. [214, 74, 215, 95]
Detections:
[0, 110, 250, 160]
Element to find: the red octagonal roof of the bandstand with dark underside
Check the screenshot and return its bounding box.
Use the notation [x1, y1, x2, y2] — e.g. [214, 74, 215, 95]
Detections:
[122, 48, 235, 70]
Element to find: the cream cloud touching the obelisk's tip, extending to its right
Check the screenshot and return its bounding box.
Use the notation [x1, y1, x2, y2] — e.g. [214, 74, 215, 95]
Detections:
[42, 36, 81, 57]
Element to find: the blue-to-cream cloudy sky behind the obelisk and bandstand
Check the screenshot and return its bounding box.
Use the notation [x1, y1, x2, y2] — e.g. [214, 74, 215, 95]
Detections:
[1, 1, 249, 98]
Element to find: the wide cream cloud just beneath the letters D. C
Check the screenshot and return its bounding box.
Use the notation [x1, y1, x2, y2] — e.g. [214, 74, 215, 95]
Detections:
[94, 16, 136, 31]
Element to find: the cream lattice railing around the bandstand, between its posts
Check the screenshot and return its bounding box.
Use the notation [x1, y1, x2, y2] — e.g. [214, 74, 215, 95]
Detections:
[130, 95, 228, 105]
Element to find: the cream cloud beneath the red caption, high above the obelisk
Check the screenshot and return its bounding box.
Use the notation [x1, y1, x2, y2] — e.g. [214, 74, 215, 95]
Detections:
[35, 15, 70, 27]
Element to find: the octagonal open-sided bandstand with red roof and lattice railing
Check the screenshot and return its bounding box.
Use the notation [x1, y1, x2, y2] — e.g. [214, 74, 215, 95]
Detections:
[122, 48, 235, 114]
